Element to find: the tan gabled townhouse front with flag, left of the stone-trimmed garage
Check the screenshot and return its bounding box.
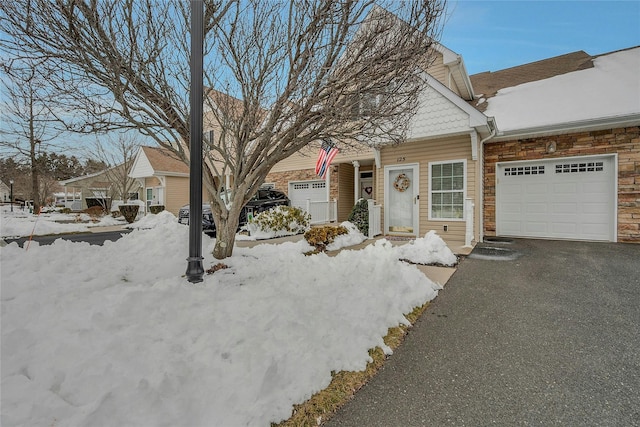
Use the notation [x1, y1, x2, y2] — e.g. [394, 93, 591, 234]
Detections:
[266, 45, 496, 251]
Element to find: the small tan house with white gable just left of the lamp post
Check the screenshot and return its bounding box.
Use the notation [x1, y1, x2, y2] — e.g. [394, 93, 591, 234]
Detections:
[129, 147, 207, 216]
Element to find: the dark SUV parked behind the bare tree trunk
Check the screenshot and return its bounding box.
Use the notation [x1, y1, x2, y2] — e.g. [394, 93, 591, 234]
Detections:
[178, 189, 291, 235]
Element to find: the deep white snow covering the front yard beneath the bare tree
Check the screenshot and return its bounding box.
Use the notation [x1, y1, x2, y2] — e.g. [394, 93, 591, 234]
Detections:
[0, 212, 455, 427]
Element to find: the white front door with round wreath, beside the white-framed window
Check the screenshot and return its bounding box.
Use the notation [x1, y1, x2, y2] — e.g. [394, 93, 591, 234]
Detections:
[384, 164, 420, 236]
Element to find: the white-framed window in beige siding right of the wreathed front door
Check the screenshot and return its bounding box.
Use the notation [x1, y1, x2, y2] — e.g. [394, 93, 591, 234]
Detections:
[429, 160, 466, 220]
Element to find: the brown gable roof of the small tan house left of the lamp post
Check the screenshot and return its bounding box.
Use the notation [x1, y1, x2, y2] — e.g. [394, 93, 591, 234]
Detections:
[129, 146, 189, 178]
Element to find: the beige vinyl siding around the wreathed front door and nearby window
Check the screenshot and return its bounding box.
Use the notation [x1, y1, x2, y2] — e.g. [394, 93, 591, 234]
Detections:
[376, 135, 479, 244]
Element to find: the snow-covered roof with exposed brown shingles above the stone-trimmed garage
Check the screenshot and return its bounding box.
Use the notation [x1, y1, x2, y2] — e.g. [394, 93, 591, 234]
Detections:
[471, 46, 640, 139]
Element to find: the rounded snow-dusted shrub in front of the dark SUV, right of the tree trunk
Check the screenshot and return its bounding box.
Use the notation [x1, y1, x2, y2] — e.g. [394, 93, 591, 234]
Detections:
[247, 206, 311, 235]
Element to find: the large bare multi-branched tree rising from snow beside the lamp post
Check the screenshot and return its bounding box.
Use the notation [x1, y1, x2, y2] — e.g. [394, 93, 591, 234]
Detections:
[0, 0, 445, 258]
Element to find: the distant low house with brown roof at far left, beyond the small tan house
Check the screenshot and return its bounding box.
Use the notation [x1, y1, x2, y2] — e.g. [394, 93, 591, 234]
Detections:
[61, 165, 138, 211]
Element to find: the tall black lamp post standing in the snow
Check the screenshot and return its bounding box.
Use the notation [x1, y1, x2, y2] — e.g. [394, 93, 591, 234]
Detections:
[186, 0, 204, 283]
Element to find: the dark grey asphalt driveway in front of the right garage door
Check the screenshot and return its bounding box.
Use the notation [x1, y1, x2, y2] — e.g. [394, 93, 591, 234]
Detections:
[325, 239, 640, 427]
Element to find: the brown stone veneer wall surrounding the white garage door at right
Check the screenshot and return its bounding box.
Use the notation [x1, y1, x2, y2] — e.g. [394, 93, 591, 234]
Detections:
[483, 126, 640, 243]
